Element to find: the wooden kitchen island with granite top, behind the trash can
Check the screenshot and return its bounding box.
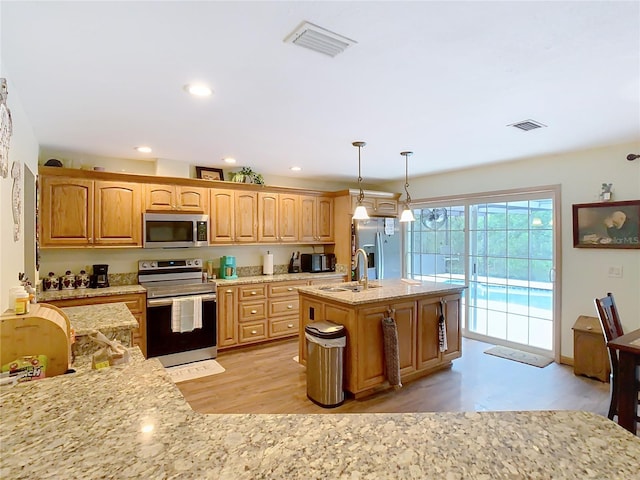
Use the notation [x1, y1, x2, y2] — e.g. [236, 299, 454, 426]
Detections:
[298, 280, 465, 398]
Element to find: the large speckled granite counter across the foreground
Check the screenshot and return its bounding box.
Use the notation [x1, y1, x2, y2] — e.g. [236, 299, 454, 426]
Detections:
[0, 350, 640, 479]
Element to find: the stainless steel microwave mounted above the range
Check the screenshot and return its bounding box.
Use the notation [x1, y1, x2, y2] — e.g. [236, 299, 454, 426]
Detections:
[142, 213, 209, 248]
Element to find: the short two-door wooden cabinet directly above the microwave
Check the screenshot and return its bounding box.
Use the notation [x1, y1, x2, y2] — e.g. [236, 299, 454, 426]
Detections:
[144, 184, 209, 213]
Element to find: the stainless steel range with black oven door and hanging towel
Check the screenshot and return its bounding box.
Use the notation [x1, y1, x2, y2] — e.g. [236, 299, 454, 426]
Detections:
[138, 258, 218, 367]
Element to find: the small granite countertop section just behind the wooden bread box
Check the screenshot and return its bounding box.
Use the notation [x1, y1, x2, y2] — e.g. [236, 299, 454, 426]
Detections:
[61, 303, 138, 336]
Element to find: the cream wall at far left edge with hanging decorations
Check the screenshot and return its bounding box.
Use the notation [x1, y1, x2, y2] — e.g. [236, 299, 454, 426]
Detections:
[0, 72, 38, 312]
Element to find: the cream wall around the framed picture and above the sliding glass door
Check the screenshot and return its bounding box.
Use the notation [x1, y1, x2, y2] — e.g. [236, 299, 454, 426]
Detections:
[384, 143, 640, 358]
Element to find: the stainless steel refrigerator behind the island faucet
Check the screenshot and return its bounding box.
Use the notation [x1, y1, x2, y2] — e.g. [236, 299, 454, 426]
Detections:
[352, 217, 402, 280]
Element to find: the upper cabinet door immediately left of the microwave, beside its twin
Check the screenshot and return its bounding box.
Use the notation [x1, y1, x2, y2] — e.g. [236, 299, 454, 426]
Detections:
[93, 181, 142, 246]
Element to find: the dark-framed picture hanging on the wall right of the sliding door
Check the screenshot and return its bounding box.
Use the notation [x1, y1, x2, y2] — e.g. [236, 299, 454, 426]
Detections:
[573, 200, 640, 249]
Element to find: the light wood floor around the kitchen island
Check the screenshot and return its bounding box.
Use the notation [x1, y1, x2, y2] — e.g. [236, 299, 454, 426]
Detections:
[178, 339, 609, 415]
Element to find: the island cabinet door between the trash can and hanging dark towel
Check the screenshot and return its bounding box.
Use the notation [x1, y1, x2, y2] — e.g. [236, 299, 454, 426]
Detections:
[356, 306, 388, 391]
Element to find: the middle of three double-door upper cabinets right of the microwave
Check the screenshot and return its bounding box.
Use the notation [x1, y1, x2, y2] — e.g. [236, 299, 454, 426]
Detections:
[258, 192, 299, 243]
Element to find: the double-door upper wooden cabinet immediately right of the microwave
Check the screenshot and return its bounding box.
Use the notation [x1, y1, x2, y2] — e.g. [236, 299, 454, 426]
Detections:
[209, 189, 258, 243]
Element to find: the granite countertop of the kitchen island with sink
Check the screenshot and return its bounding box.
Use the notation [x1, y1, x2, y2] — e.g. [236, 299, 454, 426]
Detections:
[298, 280, 466, 305]
